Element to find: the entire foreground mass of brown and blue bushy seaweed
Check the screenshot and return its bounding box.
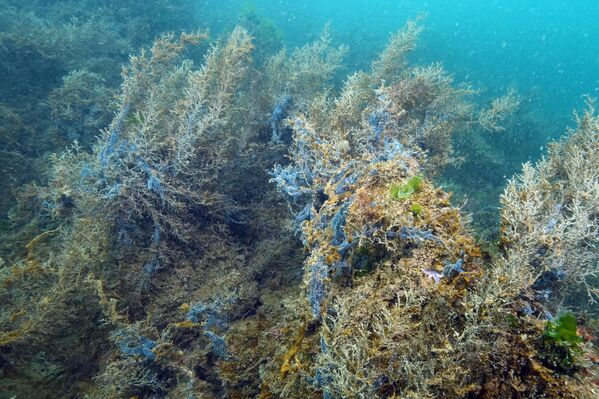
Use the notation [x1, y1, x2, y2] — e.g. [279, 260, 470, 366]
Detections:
[0, 7, 599, 398]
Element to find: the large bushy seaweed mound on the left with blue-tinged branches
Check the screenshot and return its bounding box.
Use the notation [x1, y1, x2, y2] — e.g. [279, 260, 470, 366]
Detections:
[0, 14, 350, 397]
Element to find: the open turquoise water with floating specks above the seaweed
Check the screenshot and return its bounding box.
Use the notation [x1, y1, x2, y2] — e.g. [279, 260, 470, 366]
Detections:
[201, 0, 599, 134]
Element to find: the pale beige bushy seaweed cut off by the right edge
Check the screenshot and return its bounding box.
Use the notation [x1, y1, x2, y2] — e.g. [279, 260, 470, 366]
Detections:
[501, 102, 599, 312]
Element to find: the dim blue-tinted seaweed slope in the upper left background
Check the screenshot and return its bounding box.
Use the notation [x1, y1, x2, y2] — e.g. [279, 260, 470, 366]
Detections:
[0, 0, 202, 227]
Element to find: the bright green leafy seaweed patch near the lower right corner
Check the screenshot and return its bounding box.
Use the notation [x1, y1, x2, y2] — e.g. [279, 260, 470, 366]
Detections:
[543, 312, 582, 373]
